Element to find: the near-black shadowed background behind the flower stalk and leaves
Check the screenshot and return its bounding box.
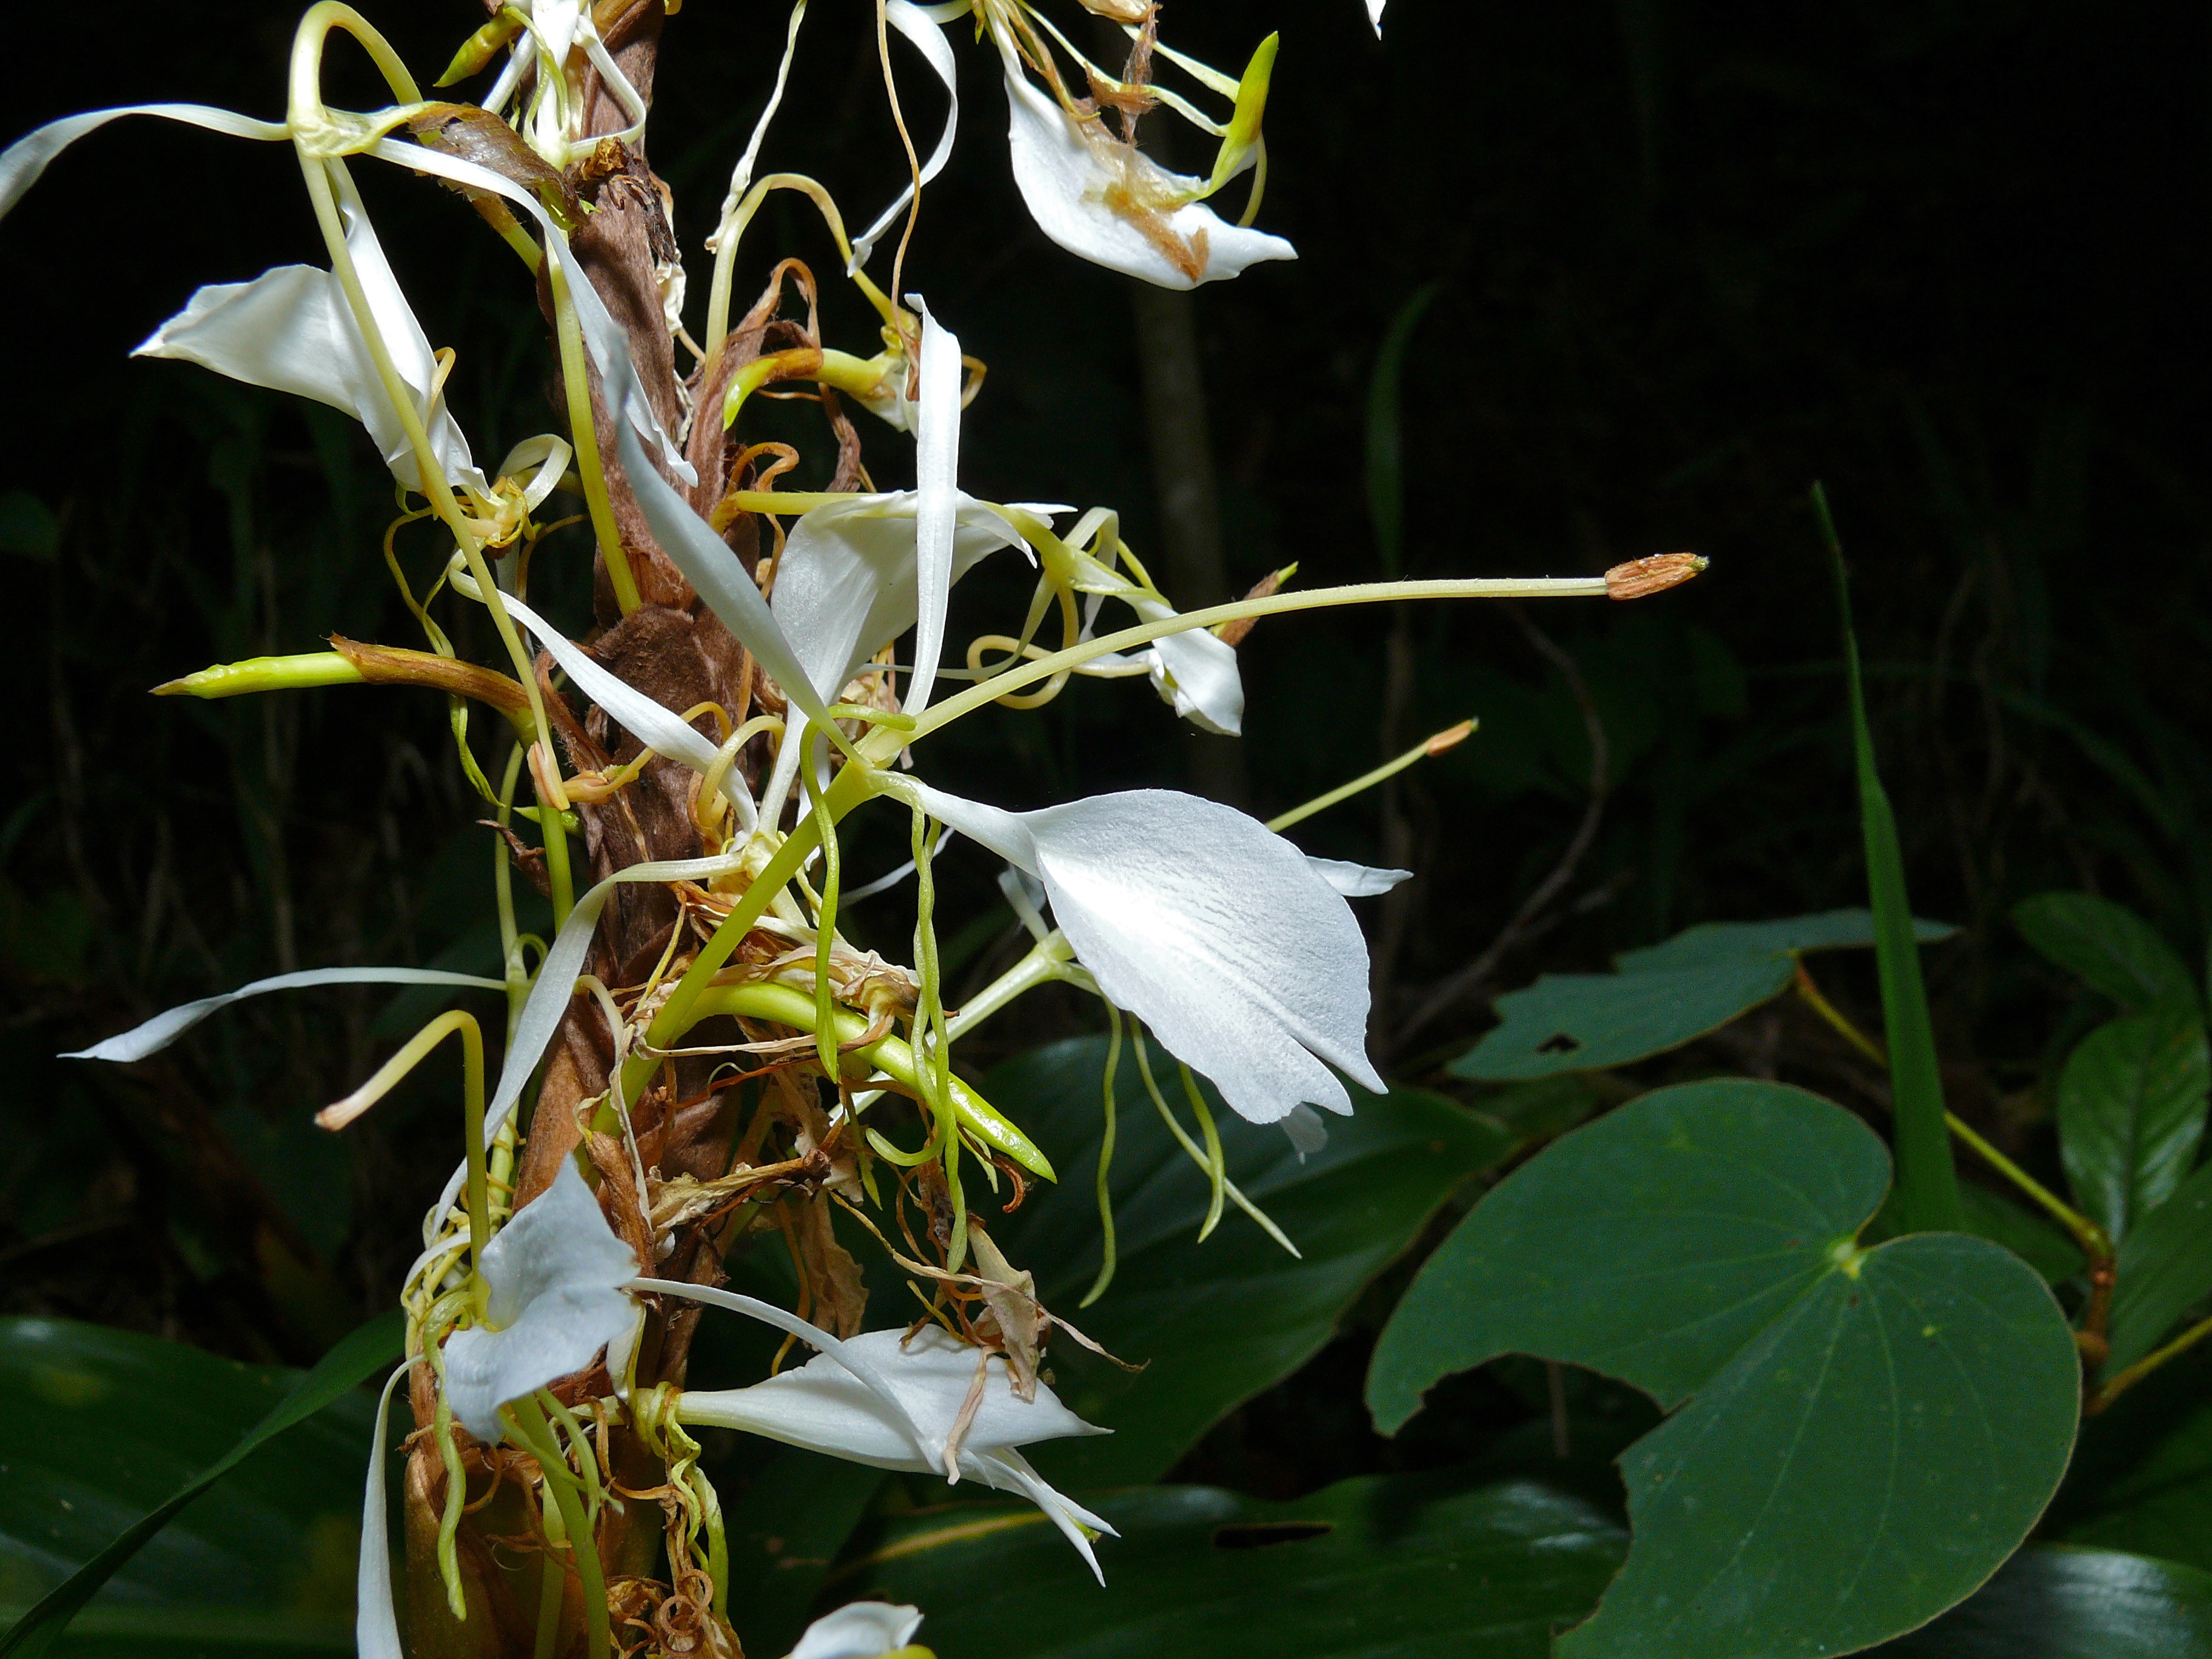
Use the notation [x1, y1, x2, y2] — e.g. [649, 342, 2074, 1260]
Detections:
[0, 0, 2212, 1478]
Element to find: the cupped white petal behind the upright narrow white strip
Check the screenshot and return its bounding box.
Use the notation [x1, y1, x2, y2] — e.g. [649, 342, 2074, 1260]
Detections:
[770, 491, 1022, 701]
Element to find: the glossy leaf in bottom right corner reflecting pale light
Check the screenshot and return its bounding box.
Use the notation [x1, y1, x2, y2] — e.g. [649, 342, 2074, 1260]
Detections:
[1867, 1546, 2212, 1659]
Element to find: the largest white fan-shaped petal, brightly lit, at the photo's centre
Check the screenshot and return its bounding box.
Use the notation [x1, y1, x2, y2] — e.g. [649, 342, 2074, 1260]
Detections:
[900, 783, 1382, 1124]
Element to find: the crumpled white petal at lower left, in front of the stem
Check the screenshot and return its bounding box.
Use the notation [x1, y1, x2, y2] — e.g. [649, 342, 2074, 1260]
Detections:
[444, 1159, 639, 1442]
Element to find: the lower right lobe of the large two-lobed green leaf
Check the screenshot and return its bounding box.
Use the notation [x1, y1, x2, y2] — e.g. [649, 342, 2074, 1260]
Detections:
[1560, 1232, 2079, 1659]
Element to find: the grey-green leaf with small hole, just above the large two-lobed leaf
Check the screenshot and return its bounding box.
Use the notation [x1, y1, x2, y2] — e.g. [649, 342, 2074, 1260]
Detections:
[1451, 909, 1953, 1082]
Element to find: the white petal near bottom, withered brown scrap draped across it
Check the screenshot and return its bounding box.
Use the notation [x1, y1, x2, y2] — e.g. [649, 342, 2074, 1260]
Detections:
[677, 1325, 1113, 1584]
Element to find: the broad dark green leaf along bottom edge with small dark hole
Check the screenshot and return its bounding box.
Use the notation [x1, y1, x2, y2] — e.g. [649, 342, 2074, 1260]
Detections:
[836, 1471, 1621, 1659]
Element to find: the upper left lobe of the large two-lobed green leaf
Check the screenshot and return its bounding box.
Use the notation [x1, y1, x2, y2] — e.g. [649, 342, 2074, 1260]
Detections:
[1367, 1079, 1889, 1433]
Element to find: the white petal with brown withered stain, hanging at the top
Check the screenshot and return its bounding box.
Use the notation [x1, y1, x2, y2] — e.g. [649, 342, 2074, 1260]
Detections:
[991, 18, 1298, 287]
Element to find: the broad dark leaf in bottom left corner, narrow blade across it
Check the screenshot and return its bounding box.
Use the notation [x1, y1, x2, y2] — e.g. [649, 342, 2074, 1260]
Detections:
[0, 1312, 403, 1655]
